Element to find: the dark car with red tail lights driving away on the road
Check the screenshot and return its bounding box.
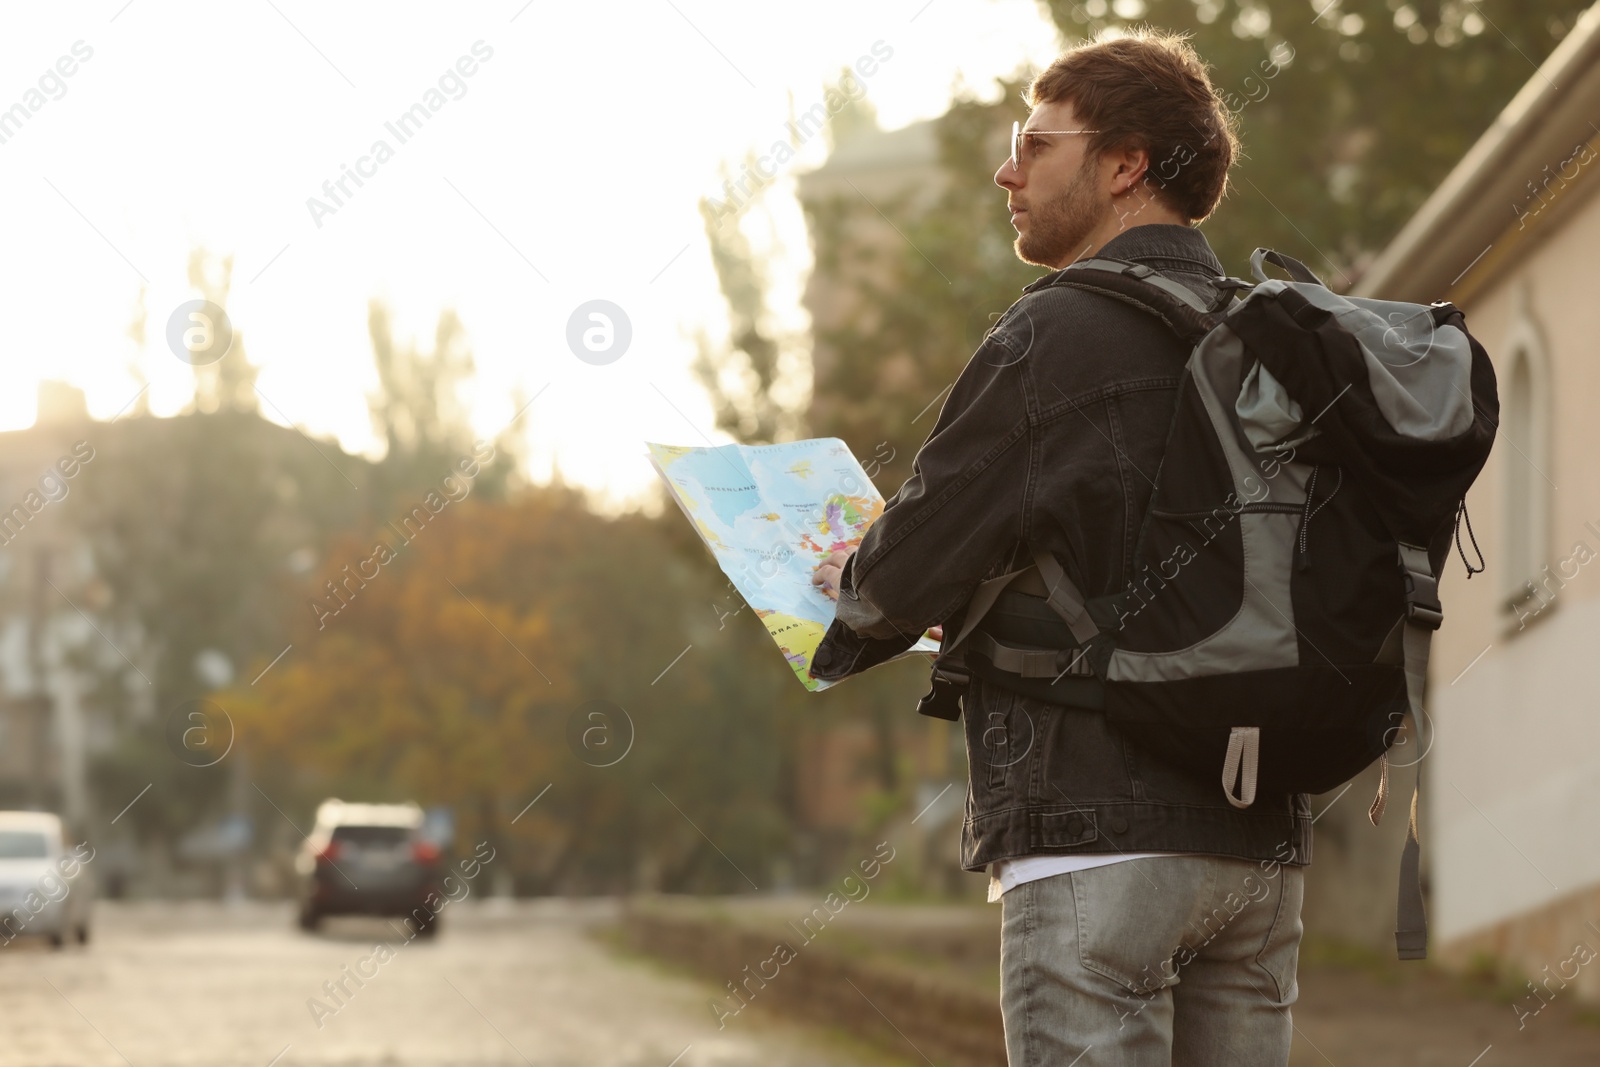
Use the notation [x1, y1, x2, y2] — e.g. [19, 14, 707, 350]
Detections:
[294, 800, 442, 936]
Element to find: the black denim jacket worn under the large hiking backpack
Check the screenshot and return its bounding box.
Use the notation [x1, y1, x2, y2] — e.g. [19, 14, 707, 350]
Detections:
[813, 224, 1310, 870]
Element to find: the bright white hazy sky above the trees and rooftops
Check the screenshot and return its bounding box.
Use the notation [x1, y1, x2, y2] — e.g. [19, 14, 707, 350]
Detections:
[9, 0, 1075, 518]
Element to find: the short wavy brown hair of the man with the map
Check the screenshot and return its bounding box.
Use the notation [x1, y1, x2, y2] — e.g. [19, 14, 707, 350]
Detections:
[1027, 30, 1238, 222]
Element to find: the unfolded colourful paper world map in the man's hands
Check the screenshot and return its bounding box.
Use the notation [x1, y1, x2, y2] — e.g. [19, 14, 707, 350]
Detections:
[646, 437, 939, 693]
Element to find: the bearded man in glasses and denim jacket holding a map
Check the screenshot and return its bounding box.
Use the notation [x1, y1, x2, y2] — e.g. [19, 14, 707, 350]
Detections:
[813, 34, 1310, 1067]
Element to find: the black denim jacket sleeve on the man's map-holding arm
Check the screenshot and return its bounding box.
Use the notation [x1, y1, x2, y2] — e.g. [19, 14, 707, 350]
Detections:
[837, 330, 1030, 651]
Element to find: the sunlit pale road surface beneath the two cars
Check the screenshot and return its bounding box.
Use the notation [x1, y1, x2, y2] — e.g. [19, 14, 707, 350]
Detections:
[0, 901, 886, 1067]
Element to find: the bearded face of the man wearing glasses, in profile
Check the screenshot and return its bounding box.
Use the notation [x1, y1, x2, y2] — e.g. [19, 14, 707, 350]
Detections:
[995, 102, 1112, 267]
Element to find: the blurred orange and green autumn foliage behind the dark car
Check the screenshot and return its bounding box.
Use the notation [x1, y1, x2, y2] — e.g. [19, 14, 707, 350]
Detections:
[230, 486, 844, 893]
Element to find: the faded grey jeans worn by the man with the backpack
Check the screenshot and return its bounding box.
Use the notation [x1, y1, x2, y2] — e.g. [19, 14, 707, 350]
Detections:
[1000, 856, 1306, 1067]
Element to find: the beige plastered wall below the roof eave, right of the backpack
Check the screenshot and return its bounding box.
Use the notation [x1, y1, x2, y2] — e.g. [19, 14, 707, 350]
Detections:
[1424, 175, 1600, 973]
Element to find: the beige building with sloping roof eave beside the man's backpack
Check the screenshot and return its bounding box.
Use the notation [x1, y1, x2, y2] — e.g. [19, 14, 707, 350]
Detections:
[1357, 6, 1600, 998]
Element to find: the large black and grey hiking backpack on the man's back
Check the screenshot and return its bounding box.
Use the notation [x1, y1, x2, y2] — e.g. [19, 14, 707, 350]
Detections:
[918, 248, 1499, 960]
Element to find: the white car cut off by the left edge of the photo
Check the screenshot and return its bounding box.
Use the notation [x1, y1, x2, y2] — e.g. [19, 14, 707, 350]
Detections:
[0, 811, 94, 949]
